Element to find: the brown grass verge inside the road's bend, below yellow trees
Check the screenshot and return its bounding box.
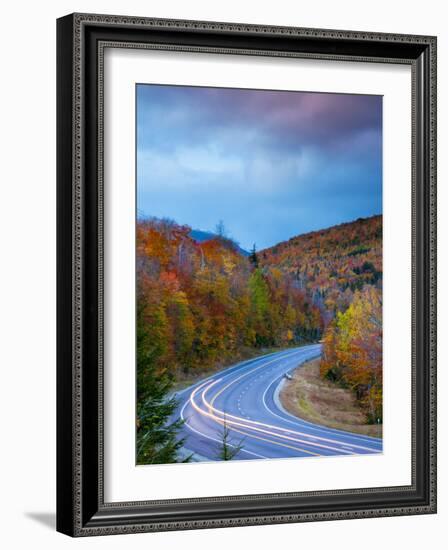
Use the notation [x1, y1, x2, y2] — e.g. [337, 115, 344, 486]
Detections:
[280, 359, 382, 437]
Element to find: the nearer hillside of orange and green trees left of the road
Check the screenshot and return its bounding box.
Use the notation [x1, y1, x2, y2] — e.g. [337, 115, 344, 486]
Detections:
[137, 218, 323, 377]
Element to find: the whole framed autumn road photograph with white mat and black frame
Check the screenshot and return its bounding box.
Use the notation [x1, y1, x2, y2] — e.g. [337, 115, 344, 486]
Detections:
[57, 14, 436, 536]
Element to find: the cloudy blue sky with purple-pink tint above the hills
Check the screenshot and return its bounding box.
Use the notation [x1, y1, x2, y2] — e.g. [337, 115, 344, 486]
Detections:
[137, 84, 382, 250]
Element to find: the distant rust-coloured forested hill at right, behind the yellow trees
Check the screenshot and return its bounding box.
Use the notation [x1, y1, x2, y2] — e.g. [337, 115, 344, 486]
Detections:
[258, 216, 383, 320]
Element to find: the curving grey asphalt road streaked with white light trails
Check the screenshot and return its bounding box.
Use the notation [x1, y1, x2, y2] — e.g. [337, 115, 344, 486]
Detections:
[174, 344, 382, 461]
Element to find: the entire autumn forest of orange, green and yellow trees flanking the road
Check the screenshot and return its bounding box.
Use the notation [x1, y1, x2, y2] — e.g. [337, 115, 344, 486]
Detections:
[137, 216, 382, 463]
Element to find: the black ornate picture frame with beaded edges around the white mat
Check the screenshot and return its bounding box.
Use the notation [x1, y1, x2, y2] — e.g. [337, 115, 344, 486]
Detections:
[57, 14, 436, 536]
